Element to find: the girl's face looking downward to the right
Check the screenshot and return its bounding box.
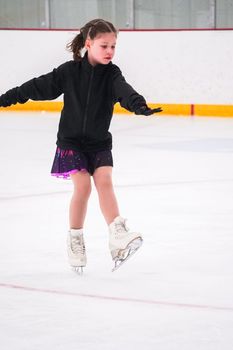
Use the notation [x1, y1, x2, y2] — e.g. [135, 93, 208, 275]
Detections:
[85, 33, 117, 66]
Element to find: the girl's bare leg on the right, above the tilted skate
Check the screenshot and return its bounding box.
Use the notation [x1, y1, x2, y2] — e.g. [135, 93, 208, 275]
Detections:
[93, 166, 120, 225]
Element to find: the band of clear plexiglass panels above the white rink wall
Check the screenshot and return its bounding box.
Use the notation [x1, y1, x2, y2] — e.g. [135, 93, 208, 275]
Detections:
[0, 0, 233, 29]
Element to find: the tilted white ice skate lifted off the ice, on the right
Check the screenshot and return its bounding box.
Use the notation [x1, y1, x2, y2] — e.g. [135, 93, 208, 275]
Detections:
[109, 216, 143, 271]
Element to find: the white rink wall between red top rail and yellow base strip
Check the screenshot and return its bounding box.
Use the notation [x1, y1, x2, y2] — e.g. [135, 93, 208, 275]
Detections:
[0, 30, 233, 104]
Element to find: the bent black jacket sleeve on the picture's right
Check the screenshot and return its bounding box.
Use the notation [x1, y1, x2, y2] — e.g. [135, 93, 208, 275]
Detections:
[113, 65, 146, 112]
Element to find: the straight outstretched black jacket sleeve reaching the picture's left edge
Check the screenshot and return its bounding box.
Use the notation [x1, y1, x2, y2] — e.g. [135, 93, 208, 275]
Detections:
[0, 65, 63, 107]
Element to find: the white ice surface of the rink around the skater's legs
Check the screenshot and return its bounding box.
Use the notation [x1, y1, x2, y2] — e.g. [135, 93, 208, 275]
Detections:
[0, 112, 233, 350]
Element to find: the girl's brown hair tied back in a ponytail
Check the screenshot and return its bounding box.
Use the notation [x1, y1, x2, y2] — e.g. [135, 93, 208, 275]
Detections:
[67, 19, 117, 61]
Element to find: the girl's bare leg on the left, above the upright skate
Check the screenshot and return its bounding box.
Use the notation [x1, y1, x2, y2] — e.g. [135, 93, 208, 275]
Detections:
[70, 171, 91, 229]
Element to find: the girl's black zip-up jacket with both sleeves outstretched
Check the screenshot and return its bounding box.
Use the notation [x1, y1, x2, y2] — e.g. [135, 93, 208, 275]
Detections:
[0, 55, 146, 151]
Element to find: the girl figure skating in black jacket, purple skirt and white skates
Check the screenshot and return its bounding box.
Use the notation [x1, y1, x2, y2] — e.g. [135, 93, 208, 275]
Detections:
[0, 19, 161, 271]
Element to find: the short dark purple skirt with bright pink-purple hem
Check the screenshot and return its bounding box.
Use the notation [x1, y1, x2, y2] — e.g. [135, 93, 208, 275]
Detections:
[51, 147, 113, 179]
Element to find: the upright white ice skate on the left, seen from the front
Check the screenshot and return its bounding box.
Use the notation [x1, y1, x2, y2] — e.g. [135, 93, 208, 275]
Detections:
[67, 229, 87, 274]
